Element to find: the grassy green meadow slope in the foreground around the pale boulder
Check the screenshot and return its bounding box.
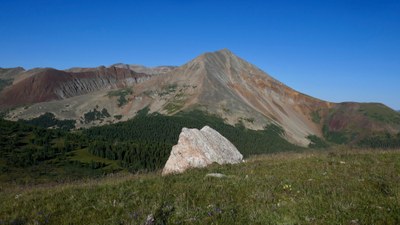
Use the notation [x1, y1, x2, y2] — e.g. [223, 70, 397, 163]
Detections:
[0, 149, 400, 224]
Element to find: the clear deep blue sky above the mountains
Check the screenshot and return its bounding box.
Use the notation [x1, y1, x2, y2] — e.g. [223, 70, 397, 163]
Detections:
[0, 0, 400, 109]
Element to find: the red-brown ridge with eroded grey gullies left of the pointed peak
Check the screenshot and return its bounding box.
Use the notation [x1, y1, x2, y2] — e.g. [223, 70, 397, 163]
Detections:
[0, 67, 149, 108]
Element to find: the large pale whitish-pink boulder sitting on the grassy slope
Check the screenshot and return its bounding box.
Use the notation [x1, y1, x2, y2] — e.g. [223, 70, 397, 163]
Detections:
[162, 126, 243, 175]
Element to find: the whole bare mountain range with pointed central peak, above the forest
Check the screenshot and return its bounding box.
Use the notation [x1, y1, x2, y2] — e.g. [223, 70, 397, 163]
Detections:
[0, 49, 400, 146]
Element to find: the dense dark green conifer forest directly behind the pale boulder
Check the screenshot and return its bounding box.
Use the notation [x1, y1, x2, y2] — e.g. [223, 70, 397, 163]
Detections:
[83, 109, 300, 157]
